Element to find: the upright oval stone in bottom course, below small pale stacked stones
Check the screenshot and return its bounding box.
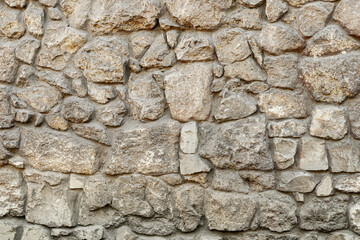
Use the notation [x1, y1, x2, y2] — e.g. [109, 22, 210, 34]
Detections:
[171, 184, 205, 232]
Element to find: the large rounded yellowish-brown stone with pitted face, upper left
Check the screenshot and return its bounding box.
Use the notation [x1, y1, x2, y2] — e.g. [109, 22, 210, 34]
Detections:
[74, 37, 129, 83]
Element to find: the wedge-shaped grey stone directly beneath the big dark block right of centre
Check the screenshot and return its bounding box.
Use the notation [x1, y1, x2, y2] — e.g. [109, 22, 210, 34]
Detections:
[211, 169, 249, 193]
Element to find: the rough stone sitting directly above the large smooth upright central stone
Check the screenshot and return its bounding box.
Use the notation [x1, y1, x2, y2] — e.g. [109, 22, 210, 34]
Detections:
[175, 31, 214, 62]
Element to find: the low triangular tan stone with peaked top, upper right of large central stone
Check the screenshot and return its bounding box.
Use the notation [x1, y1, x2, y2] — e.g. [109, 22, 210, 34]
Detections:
[224, 57, 267, 81]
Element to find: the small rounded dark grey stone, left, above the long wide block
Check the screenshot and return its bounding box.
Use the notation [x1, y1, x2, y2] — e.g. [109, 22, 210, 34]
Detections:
[61, 97, 94, 123]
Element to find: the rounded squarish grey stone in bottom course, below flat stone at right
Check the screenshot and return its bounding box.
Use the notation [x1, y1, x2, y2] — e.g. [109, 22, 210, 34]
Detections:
[258, 191, 297, 232]
